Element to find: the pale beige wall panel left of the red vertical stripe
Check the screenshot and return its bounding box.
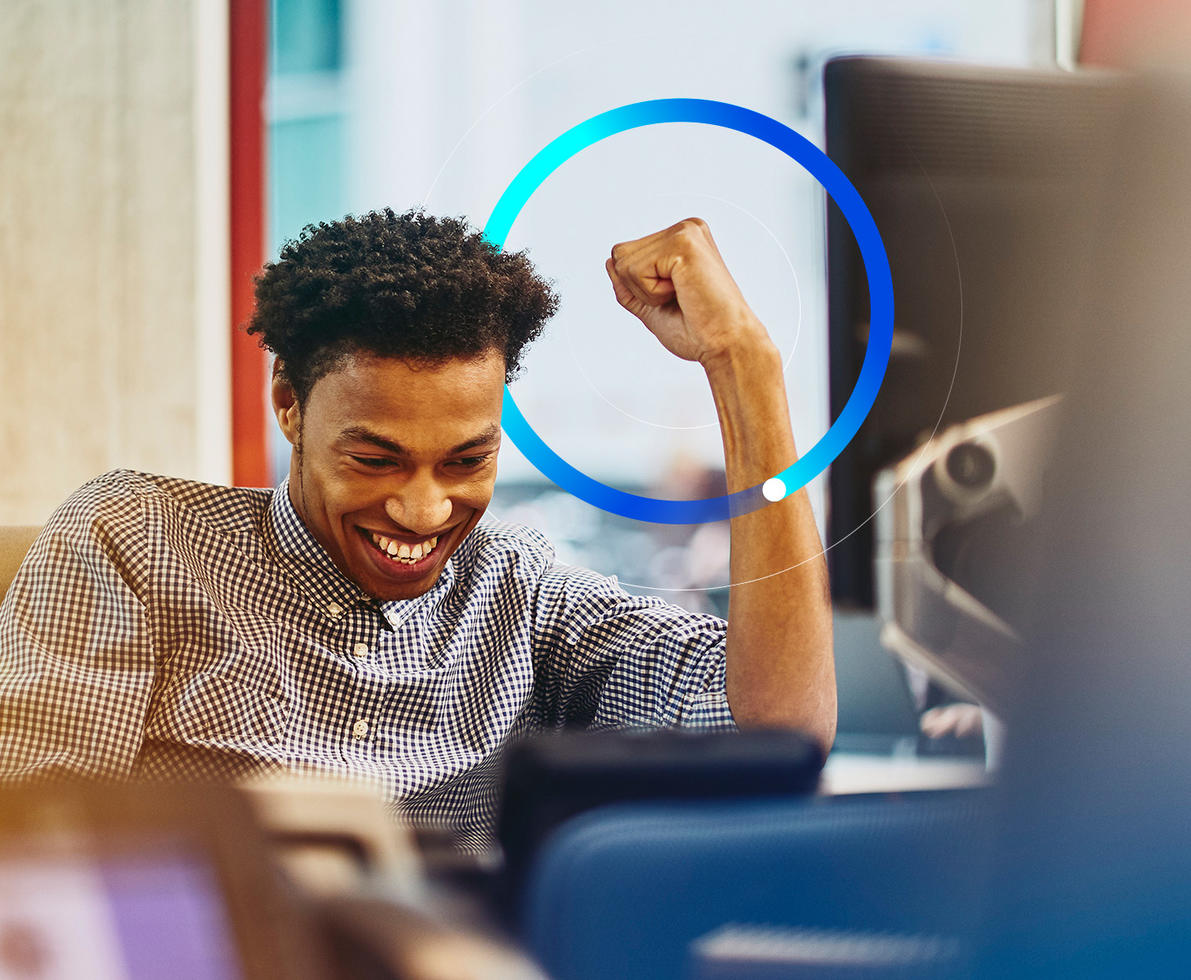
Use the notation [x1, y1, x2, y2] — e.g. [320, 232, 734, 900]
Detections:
[0, 0, 231, 523]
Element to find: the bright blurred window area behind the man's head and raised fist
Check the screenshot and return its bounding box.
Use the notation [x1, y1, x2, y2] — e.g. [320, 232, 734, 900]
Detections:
[268, 0, 1055, 612]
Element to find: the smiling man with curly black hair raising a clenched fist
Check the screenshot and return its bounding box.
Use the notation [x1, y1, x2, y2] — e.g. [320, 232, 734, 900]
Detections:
[0, 210, 835, 847]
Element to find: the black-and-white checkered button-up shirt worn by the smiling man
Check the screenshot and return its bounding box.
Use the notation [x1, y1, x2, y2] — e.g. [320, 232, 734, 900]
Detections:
[0, 470, 734, 849]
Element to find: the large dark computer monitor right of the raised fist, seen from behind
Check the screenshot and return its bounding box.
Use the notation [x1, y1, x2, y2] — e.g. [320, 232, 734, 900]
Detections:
[824, 57, 1121, 608]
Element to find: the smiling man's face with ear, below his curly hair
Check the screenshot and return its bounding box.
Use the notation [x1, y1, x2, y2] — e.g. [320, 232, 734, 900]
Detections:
[273, 350, 505, 600]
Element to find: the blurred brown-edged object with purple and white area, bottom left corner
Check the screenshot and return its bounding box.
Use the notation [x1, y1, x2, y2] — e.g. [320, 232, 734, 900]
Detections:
[0, 784, 328, 980]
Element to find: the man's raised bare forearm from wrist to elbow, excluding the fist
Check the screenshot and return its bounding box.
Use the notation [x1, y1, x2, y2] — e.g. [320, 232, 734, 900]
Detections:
[704, 333, 836, 749]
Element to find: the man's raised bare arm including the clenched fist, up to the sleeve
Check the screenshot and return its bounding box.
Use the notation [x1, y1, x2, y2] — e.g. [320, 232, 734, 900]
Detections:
[606, 219, 836, 750]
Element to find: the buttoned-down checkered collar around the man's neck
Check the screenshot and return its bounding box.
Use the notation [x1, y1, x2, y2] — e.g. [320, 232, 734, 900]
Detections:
[264, 477, 455, 626]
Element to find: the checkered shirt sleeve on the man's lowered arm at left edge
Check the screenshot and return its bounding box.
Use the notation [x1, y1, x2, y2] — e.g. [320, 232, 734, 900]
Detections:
[0, 474, 155, 780]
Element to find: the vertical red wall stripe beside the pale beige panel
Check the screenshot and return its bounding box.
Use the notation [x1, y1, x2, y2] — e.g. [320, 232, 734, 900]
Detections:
[227, 0, 270, 487]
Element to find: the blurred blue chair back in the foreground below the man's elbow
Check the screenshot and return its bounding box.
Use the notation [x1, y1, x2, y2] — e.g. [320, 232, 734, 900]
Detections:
[520, 789, 992, 980]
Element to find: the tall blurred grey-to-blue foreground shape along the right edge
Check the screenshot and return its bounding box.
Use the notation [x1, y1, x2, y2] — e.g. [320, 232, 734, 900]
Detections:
[981, 76, 1191, 978]
